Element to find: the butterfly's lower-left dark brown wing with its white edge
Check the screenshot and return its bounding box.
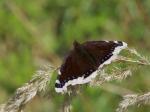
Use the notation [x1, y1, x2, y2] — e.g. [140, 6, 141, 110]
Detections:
[55, 47, 96, 92]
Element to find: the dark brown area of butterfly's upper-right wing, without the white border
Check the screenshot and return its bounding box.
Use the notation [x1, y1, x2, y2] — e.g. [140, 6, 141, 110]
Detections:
[83, 41, 118, 67]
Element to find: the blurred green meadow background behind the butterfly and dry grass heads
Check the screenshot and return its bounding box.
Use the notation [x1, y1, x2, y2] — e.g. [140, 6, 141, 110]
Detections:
[0, 0, 150, 112]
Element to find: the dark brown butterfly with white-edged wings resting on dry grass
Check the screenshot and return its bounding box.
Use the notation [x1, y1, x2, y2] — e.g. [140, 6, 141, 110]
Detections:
[55, 41, 127, 93]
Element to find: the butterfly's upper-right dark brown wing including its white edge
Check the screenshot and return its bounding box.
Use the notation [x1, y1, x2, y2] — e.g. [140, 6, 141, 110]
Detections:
[83, 41, 127, 67]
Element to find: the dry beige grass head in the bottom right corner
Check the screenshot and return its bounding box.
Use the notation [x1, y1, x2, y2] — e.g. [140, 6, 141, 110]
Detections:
[116, 92, 150, 112]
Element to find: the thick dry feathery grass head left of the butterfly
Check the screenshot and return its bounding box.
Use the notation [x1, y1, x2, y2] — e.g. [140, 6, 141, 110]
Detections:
[0, 66, 53, 112]
